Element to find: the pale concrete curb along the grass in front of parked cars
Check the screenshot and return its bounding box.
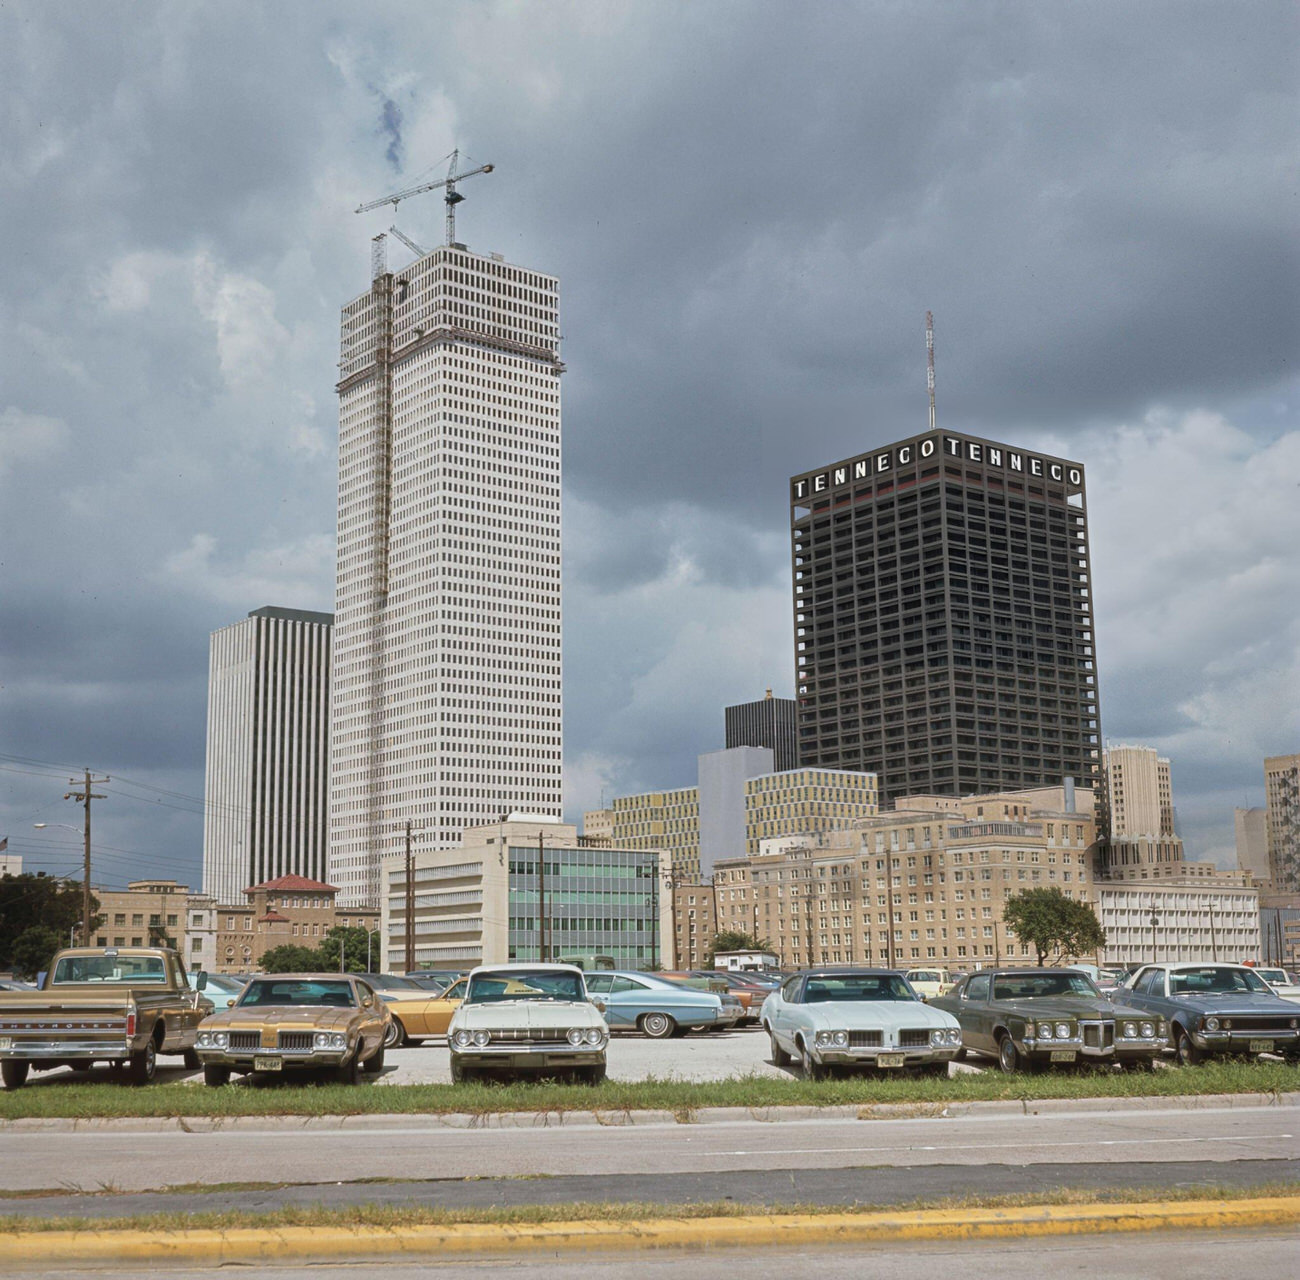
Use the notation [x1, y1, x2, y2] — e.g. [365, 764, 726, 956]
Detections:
[0, 1092, 1300, 1133]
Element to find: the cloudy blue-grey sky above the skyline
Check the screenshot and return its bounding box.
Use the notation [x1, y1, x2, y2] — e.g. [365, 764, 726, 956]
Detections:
[0, 0, 1300, 885]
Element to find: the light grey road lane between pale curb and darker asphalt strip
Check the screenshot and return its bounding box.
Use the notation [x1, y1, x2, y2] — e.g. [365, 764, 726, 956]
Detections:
[0, 1102, 1300, 1192]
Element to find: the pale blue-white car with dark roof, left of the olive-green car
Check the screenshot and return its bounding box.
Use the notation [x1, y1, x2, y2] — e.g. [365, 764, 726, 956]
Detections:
[762, 968, 962, 1080]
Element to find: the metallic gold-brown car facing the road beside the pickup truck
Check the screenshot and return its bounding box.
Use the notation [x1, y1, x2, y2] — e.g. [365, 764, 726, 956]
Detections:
[195, 973, 390, 1086]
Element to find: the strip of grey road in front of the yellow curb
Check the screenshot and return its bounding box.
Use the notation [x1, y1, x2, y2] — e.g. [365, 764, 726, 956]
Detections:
[8, 1229, 1296, 1280]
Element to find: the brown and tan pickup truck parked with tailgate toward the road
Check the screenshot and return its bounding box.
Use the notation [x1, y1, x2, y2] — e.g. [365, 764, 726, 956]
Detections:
[0, 947, 212, 1089]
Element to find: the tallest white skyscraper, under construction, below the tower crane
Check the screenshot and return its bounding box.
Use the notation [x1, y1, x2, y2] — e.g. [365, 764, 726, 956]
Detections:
[329, 235, 564, 906]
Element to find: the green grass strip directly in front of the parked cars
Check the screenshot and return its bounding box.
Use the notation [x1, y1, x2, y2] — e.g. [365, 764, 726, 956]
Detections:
[0, 1062, 1300, 1121]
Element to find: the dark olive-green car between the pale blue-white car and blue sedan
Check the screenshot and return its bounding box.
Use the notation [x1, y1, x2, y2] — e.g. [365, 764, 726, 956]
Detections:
[931, 968, 1169, 1071]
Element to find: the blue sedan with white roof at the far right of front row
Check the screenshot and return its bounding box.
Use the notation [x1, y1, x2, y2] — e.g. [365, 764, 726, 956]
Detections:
[1121, 964, 1300, 1066]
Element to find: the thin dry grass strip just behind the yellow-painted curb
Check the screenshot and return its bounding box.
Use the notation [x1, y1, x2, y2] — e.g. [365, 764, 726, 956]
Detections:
[0, 1176, 1300, 1237]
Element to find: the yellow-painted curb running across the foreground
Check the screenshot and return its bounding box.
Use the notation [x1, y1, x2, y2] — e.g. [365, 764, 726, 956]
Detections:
[0, 1197, 1300, 1266]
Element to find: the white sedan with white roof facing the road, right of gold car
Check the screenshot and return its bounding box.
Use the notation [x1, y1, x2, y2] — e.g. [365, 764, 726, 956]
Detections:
[447, 963, 610, 1084]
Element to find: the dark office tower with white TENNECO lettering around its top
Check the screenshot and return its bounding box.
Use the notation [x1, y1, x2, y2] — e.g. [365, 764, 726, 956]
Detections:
[790, 431, 1101, 807]
